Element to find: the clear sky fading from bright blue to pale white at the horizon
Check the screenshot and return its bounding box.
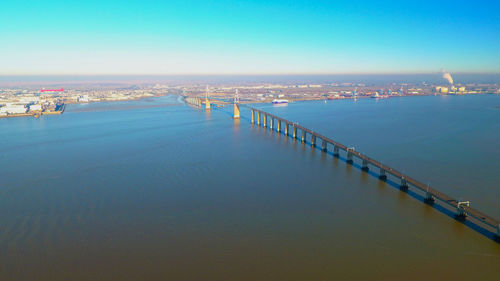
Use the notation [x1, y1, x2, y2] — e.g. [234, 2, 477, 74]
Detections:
[0, 0, 500, 75]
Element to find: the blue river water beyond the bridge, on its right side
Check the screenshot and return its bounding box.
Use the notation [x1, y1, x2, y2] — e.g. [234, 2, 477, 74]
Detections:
[254, 95, 500, 214]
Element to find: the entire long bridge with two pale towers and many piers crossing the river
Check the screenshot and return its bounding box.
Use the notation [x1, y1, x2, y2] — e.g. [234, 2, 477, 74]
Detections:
[185, 93, 500, 242]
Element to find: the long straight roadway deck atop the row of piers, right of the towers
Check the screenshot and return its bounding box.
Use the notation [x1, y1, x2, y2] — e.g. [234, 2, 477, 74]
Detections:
[246, 106, 500, 229]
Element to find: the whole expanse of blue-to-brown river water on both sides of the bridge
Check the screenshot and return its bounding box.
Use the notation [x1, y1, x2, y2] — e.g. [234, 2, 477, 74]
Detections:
[0, 95, 500, 280]
